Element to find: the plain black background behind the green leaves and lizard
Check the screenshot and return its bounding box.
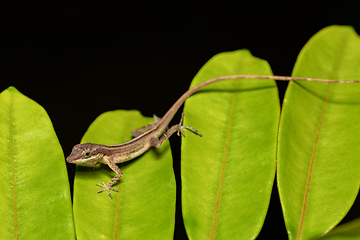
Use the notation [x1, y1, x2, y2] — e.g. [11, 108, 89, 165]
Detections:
[0, 1, 360, 239]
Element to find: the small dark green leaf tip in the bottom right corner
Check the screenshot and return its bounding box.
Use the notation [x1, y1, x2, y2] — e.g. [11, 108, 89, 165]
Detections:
[320, 218, 360, 240]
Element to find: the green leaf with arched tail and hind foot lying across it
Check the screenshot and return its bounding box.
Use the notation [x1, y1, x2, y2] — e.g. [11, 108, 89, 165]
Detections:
[181, 50, 280, 240]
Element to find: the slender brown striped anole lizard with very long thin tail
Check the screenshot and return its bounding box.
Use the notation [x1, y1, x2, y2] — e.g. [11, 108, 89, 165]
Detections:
[66, 75, 360, 198]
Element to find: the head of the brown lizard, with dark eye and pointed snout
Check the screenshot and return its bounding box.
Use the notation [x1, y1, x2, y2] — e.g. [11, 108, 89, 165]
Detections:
[66, 143, 104, 164]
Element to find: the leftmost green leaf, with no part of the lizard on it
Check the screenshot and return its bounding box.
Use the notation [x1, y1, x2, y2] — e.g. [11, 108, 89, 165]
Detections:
[0, 87, 75, 240]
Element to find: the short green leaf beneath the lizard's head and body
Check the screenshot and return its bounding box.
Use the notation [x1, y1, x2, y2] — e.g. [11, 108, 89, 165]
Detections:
[74, 110, 176, 240]
